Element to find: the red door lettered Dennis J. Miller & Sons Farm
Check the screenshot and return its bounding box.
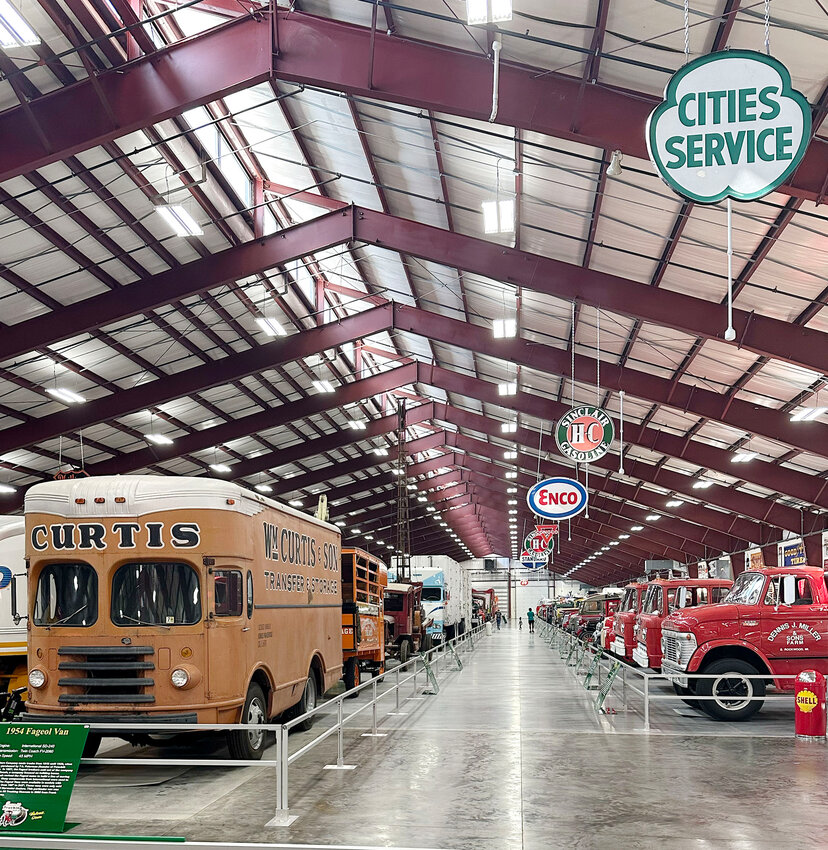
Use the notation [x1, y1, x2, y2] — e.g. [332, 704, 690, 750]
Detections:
[761, 572, 828, 688]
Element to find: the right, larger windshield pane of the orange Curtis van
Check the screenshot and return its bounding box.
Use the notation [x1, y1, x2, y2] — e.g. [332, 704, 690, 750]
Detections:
[111, 562, 201, 626]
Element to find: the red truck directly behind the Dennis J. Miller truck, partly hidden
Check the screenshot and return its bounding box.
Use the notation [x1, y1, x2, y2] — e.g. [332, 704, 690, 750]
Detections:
[633, 578, 733, 670]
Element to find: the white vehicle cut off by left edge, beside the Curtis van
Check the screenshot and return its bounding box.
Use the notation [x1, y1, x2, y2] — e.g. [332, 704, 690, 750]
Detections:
[0, 516, 28, 693]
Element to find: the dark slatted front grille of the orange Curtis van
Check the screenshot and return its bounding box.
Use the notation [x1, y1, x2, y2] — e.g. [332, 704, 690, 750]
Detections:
[58, 646, 155, 705]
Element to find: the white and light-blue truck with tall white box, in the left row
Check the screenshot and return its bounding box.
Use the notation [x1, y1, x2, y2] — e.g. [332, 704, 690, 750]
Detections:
[411, 555, 472, 643]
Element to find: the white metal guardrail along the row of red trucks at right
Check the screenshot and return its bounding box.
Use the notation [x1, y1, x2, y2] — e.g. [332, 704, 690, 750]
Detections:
[538, 620, 796, 732]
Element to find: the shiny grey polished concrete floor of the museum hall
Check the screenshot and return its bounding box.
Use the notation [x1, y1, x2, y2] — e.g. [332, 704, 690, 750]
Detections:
[48, 628, 828, 850]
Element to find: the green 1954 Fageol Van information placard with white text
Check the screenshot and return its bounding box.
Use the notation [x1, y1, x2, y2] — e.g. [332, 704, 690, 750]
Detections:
[0, 723, 89, 836]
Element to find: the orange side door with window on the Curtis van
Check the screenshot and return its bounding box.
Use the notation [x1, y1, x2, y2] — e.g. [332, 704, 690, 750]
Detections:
[206, 568, 247, 700]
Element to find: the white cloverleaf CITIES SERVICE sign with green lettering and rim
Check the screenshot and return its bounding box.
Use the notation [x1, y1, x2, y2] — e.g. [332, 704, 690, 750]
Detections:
[647, 50, 811, 204]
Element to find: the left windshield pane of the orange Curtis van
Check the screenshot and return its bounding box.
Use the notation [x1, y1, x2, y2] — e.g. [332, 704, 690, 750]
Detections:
[33, 563, 98, 626]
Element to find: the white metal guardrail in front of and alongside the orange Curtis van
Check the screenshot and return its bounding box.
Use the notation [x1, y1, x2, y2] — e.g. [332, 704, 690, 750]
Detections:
[11, 626, 485, 828]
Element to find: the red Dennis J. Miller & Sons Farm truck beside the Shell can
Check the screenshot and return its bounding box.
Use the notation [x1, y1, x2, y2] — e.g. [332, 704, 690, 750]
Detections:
[662, 566, 828, 720]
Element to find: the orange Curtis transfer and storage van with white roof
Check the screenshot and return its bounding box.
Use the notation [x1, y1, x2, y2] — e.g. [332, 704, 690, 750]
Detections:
[21, 475, 342, 759]
